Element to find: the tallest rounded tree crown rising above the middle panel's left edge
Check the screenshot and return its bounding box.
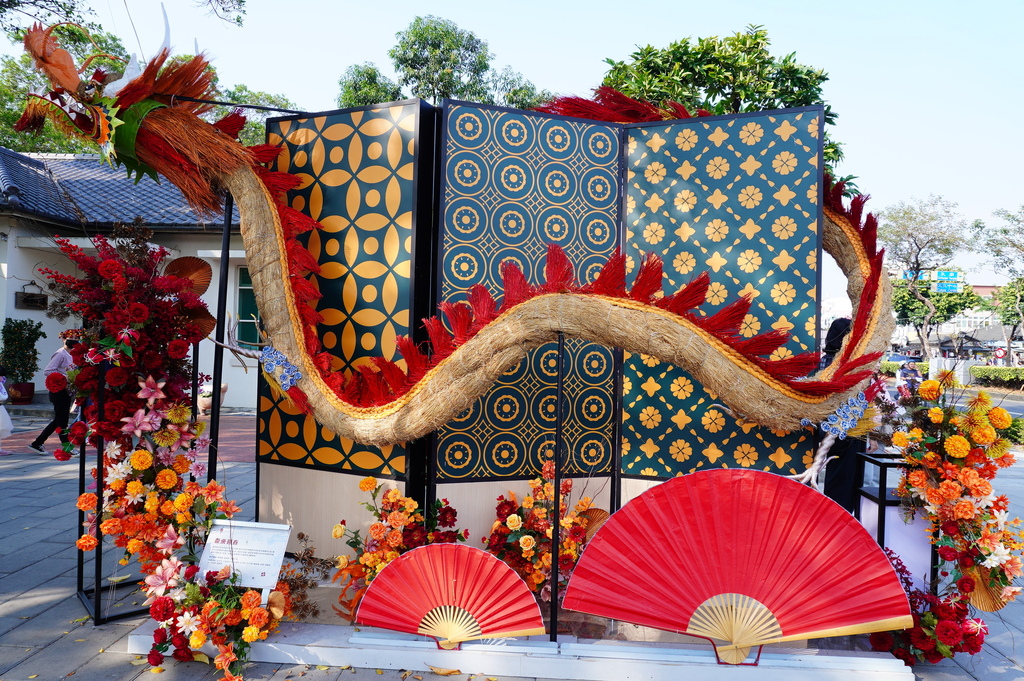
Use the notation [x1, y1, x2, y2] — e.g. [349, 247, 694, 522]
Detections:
[388, 15, 492, 103]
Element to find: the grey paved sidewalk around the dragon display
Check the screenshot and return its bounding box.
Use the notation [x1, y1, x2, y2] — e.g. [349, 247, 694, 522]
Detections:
[0, 406, 1024, 681]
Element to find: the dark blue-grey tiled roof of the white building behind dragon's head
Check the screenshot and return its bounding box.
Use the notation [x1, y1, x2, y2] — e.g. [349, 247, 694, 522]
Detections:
[0, 147, 238, 229]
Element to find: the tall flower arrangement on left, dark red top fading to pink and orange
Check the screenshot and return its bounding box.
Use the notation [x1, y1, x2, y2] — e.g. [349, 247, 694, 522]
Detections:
[41, 226, 290, 681]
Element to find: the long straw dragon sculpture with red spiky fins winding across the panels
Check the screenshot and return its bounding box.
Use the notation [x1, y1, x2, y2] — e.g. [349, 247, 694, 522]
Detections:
[17, 25, 893, 444]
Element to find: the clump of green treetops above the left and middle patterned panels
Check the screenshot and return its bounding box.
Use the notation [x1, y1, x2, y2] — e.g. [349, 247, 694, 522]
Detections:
[338, 15, 551, 109]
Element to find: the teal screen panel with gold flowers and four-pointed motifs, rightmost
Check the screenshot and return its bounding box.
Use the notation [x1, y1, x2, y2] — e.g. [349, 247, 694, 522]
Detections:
[621, 108, 822, 477]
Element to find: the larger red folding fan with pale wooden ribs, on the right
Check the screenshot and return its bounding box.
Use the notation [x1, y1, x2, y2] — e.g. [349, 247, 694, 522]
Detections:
[563, 469, 913, 664]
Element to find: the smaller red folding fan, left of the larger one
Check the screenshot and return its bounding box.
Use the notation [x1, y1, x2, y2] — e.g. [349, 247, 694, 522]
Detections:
[355, 544, 545, 648]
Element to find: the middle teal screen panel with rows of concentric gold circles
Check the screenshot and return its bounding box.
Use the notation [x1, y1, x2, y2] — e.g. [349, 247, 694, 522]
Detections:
[435, 102, 622, 481]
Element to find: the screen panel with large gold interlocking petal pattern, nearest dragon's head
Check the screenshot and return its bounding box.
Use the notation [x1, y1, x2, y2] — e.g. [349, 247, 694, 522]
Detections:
[258, 101, 421, 476]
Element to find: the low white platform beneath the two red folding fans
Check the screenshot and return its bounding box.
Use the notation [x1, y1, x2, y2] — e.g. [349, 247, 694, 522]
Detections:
[128, 620, 914, 681]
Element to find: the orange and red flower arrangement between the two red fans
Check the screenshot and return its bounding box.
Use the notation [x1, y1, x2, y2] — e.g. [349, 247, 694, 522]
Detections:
[483, 459, 593, 601]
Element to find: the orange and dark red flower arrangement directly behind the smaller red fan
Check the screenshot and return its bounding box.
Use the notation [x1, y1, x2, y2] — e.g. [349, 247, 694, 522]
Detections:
[331, 476, 469, 622]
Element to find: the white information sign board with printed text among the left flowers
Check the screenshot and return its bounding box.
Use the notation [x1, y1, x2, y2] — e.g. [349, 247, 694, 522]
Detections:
[199, 520, 292, 589]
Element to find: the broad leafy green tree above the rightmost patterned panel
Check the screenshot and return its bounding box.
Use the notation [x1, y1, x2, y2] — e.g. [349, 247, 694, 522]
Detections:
[602, 25, 843, 166]
